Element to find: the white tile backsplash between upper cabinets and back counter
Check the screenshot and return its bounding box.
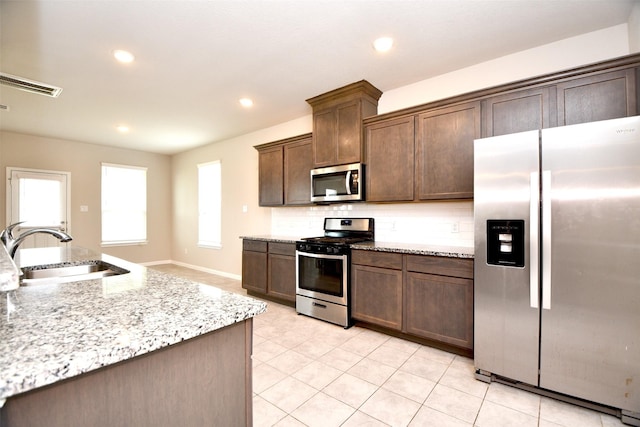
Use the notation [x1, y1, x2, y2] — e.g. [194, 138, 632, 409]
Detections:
[271, 201, 473, 247]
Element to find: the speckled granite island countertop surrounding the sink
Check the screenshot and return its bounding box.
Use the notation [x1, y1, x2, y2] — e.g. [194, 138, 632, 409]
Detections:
[0, 247, 266, 407]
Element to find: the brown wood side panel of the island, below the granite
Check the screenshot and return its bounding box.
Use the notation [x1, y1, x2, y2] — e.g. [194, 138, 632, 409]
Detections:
[0, 319, 253, 427]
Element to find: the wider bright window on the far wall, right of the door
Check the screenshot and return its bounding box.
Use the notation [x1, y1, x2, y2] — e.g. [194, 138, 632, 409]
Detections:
[102, 163, 147, 245]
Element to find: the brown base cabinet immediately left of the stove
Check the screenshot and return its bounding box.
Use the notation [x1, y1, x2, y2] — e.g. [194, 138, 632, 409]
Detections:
[267, 242, 296, 301]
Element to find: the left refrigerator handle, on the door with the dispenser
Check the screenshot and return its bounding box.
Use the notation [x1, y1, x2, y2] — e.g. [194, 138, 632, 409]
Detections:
[529, 172, 540, 308]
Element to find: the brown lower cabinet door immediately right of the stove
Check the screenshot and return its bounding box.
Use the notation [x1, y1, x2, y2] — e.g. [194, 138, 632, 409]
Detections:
[351, 264, 402, 331]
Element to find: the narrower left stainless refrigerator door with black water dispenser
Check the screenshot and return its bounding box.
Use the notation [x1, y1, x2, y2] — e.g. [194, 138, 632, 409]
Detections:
[474, 131, 540, 385]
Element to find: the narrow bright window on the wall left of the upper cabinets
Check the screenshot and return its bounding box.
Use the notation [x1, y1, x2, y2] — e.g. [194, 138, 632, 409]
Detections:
[198, 161, 222, 248]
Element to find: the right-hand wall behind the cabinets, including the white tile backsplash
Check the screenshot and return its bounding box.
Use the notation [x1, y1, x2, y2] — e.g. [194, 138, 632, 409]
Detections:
[172, 24, 631, 276]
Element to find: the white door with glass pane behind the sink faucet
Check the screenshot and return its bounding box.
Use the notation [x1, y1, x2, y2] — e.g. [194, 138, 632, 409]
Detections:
[6, 167, 70, 248]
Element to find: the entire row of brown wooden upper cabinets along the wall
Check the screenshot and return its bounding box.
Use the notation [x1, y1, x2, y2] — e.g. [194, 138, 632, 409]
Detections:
[256, 54, 640, 206]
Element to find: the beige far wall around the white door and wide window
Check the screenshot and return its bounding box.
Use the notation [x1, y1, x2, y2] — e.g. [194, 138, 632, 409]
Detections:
[0, 131, 172, 263]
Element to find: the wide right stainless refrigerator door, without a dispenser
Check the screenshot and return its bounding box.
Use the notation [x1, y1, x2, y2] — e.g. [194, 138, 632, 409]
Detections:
[540, 117, 640, 412]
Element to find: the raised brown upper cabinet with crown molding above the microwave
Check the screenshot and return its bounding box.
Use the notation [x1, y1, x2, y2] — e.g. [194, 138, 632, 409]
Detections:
[307, 80, 382, 167]
